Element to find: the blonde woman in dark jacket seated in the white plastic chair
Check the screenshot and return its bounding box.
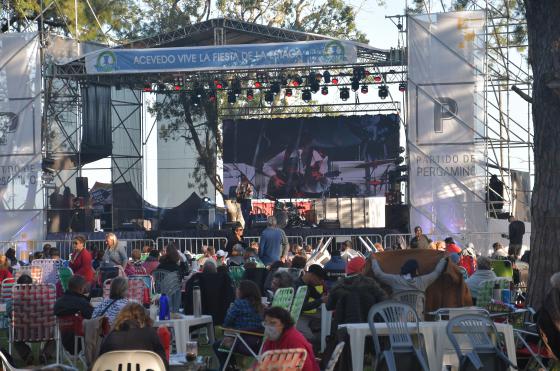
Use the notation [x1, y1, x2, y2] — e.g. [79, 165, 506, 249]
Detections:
[99, 303, 169, 370]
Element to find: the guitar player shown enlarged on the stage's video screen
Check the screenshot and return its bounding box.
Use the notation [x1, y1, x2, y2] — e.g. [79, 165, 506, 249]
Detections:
[263, 136, 328, 197]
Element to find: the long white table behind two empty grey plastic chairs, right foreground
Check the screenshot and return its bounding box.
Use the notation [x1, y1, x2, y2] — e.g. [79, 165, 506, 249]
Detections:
[339, 321, 517, 371]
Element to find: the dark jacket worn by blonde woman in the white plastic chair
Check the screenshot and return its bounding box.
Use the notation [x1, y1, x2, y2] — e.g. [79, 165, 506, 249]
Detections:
[99, 325, 169, 370]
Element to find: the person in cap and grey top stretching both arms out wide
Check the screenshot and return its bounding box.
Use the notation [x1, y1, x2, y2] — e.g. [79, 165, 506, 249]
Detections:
[371, 258, 448, 294]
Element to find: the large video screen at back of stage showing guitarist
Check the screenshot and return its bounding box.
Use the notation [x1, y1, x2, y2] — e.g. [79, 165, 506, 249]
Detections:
[223, 114, 399, 198]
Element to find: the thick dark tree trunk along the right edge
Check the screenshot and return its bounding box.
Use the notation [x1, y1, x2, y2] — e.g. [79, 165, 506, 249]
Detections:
[524, 0, 560, 309]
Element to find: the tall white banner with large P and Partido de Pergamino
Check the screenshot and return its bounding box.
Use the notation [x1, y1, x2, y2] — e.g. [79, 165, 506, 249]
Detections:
[407, 11, 487, 235]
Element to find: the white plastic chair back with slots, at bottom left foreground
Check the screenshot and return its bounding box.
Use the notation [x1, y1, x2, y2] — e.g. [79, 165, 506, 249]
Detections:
[91, 350, 165, 371]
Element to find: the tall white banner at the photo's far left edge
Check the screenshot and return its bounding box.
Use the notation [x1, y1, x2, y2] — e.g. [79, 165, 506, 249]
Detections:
[0, 33, 44, 244]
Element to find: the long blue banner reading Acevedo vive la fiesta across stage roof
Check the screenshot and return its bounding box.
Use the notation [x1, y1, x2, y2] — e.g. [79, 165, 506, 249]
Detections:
[86, 40, 357, 74]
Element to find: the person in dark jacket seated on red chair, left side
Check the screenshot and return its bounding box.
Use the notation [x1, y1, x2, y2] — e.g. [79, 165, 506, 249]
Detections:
[54, 275, 93, 354]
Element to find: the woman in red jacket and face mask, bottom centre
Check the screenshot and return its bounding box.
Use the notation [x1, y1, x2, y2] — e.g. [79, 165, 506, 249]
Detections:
[262, 307, 319, 371]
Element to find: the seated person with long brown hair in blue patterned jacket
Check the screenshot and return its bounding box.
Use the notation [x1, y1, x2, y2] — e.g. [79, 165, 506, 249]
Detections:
[214, 280, 264, 370]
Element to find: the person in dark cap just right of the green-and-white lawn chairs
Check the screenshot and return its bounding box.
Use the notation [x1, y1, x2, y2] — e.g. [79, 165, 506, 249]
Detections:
[296, 264, 327, 348]
